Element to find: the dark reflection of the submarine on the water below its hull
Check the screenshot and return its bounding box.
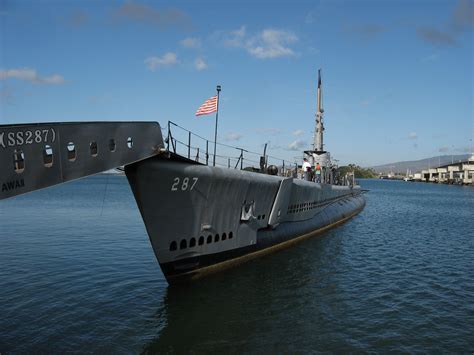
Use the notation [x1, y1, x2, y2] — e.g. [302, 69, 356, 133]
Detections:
[143, 231, 340, 353]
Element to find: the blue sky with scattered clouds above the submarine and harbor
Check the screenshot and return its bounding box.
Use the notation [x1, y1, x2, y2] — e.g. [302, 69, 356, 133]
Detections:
[0, 0, 474, 166]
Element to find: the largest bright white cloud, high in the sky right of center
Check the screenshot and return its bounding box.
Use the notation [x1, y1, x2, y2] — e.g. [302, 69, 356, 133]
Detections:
[246, 29, 298, 59]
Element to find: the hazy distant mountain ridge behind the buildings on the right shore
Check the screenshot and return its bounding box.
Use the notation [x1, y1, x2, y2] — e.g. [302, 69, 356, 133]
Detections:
[371, 154, 471, 175]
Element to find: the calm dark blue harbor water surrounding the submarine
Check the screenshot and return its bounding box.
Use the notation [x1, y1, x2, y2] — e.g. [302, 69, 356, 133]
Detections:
[0, 175, 474, 354]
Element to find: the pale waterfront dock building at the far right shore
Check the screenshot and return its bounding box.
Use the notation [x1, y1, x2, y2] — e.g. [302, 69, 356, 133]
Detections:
[420, 154, 474, 185]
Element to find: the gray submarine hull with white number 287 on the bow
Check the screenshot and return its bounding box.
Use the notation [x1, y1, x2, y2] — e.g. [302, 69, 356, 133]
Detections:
[125, 155, 365, 283]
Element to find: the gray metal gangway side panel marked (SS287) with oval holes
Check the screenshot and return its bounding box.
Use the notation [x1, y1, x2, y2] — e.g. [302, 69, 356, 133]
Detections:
[0, 122, 164, 200]
